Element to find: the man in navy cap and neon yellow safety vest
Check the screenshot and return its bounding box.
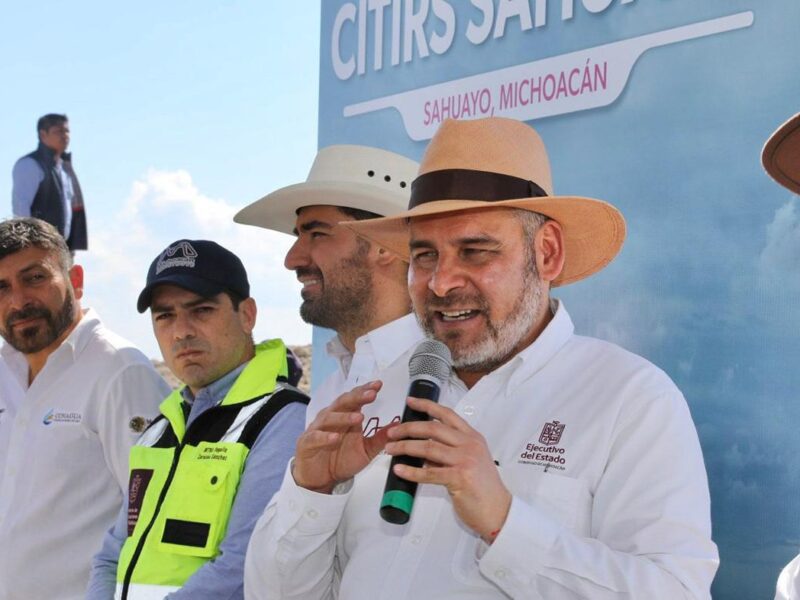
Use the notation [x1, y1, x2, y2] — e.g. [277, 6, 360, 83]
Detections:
[87, 240, 308, 600]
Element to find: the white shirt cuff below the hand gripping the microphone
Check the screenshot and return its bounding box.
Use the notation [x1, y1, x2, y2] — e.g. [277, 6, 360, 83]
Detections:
[476, 496, 561, 597]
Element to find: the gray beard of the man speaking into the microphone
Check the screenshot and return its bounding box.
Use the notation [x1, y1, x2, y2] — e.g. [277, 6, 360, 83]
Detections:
[417, 261, 546, 373]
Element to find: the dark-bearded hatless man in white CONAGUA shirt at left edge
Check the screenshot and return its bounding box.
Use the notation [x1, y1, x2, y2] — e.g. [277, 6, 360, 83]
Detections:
[0, 218, 169, 600]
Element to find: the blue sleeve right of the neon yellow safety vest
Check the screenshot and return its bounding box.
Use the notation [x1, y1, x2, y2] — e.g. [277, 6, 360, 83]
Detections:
[167, 402, 306, 600]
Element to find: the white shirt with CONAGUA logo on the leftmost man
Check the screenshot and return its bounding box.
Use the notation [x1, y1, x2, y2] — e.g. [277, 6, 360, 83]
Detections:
[0, 310, 169, 600]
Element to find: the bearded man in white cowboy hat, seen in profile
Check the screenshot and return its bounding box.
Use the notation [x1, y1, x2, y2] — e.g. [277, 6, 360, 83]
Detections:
[234, 145, 423, 426]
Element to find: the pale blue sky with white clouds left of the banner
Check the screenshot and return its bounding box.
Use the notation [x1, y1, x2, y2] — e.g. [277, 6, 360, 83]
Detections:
[0, 0, 320, 357]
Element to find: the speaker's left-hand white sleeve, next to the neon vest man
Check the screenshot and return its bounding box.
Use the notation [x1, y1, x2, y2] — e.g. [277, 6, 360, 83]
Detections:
[244, 465, 353, 600]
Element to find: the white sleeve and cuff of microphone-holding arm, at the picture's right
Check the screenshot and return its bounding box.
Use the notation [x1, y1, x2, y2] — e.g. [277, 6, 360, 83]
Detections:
[476, 390, 719, 600]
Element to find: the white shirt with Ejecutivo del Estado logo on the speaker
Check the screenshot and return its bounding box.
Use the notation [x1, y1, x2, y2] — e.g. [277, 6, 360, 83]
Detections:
[245, 306, 718, 600]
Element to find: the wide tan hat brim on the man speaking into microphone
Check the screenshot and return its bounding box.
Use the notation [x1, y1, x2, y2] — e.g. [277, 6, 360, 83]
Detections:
[342, 196, 626, 286]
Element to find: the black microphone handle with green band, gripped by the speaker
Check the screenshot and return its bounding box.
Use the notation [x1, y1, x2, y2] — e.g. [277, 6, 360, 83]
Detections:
[380, 379, 439, 525]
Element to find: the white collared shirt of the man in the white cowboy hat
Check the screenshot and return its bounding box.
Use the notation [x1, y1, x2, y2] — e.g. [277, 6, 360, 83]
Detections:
[306, 313, 425, 424]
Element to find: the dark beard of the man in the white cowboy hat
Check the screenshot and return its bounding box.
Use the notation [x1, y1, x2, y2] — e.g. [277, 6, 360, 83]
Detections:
[300, 245, 375, 338]
